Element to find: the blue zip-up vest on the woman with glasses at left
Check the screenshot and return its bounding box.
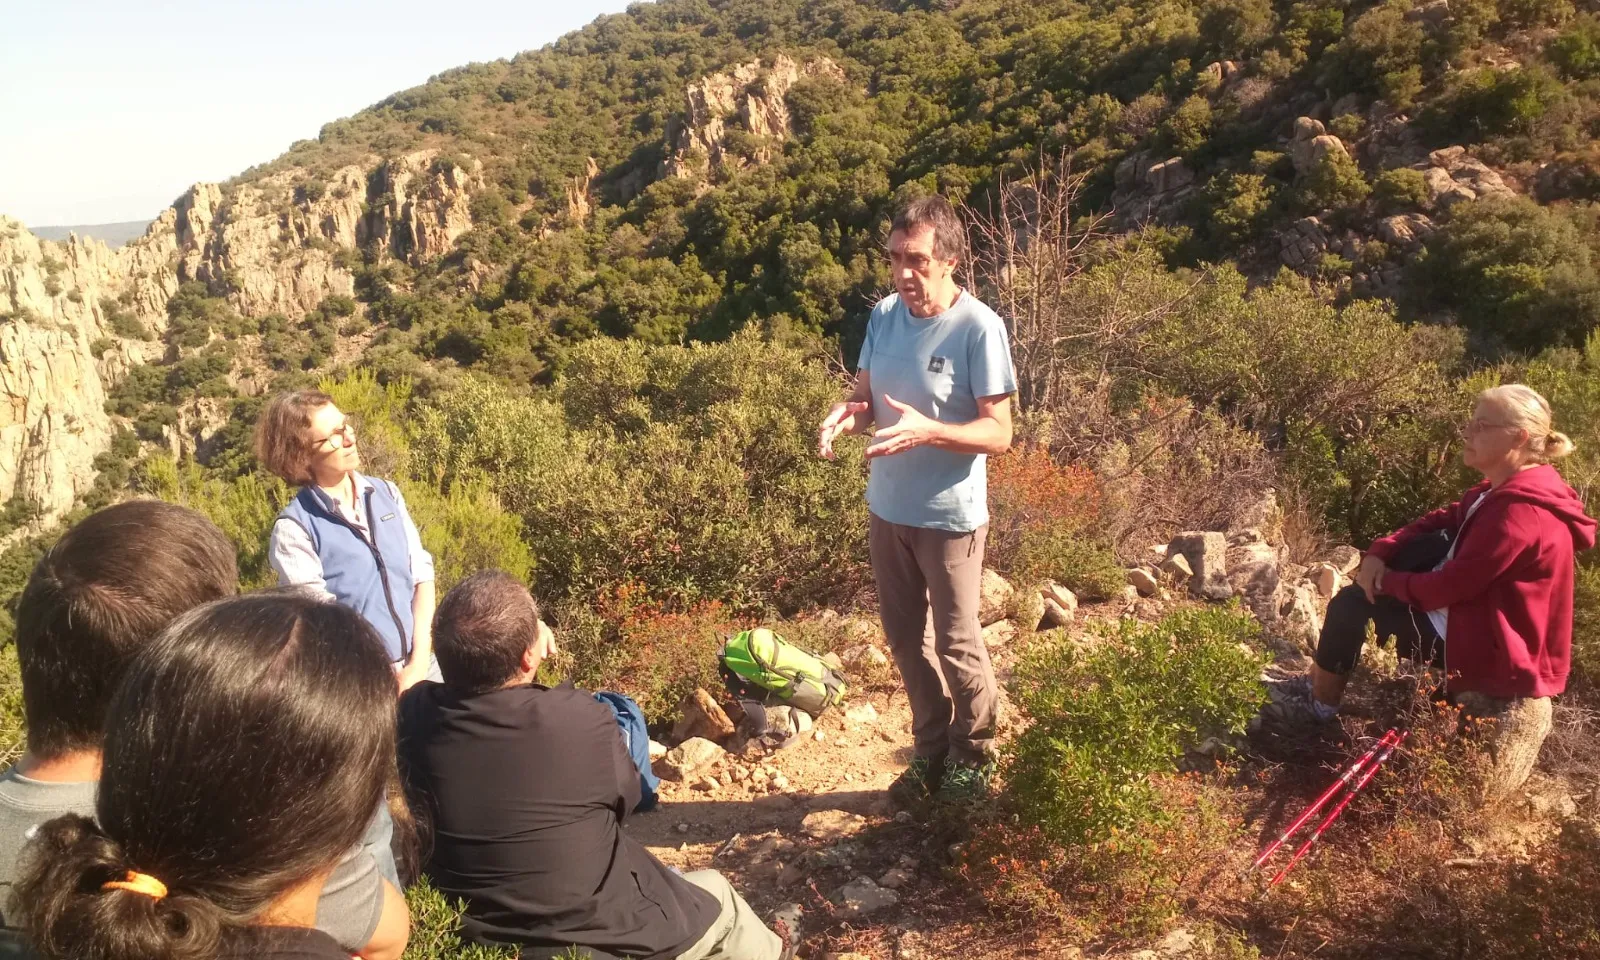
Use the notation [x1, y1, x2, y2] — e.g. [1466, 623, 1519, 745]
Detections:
[278, 474, 416, 661]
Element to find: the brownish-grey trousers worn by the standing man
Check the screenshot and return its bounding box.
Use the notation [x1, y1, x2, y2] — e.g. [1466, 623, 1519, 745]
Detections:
[867, 514, 998, 763]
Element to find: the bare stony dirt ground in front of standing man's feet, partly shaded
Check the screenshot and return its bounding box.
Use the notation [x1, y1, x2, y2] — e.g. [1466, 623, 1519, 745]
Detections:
[627, 633, 1077, 960]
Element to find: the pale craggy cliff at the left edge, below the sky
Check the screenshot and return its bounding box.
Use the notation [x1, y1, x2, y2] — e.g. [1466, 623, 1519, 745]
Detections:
[0, 150, 483, 520]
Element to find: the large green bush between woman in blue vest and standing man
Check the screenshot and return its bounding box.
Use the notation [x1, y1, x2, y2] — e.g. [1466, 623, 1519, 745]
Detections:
[413, 334, 867, 611]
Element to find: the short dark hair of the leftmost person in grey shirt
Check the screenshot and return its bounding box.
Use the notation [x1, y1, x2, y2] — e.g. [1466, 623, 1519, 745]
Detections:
[16, 501, 238, 757]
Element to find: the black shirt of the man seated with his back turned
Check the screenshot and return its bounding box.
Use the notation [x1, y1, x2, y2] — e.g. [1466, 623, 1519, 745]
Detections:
[400, 682, 720, 958]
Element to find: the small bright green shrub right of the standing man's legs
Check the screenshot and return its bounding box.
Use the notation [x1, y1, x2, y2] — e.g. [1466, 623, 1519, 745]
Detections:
[1003, 608, 1264, 843]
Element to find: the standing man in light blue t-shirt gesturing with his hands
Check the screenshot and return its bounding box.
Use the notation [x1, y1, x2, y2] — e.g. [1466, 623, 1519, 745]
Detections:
[818, 197, 1016, 803]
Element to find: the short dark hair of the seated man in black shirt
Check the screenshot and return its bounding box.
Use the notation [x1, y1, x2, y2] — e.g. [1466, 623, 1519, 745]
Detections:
[434, 570, 539, 696]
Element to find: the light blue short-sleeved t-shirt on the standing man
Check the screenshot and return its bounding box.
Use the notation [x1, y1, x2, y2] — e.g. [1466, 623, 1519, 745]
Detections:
[859, 290, 1016, 533]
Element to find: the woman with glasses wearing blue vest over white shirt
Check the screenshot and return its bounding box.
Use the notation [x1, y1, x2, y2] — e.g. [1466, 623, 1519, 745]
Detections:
[256, 390, 438, 690]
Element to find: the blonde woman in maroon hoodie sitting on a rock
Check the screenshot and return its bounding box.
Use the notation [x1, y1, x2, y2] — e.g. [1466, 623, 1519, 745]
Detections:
[1301, 384, 1595, 720]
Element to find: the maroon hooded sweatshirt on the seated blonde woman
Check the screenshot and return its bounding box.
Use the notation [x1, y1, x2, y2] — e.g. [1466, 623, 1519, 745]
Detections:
[1368, 464, 1595, 698]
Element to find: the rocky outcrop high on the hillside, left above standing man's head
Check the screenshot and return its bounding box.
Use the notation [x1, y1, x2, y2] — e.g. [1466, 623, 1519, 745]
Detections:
[661, 54, 845, 178]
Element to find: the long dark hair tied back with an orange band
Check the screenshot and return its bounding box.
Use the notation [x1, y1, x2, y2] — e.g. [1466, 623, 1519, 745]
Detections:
[13, 592, 395, 960]
